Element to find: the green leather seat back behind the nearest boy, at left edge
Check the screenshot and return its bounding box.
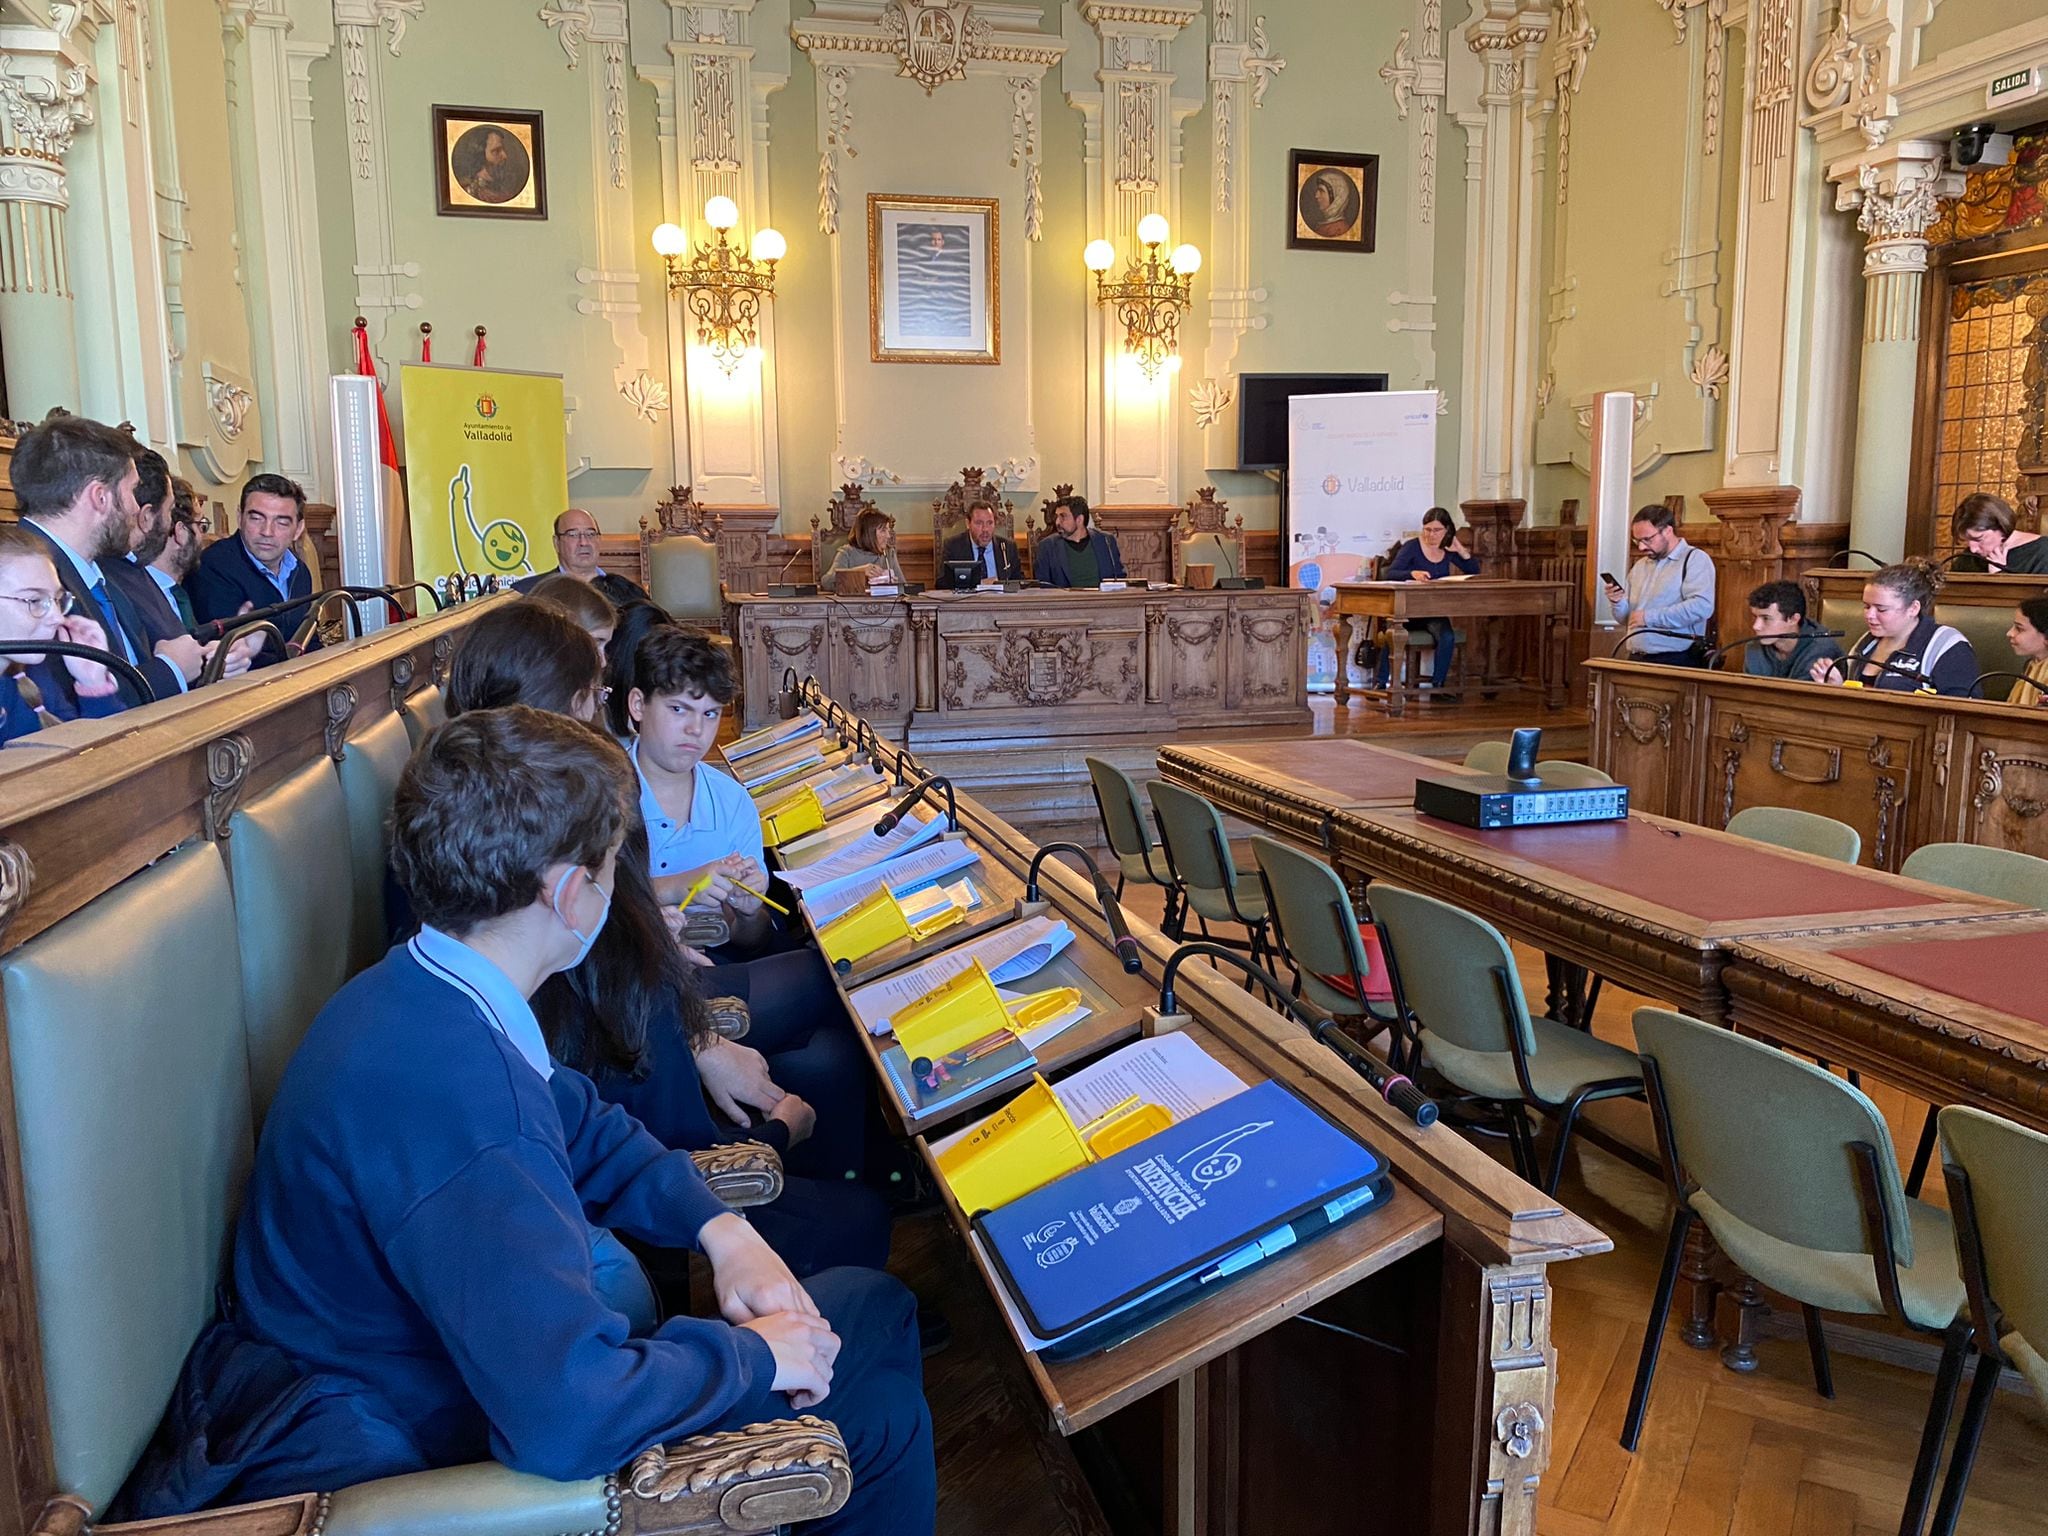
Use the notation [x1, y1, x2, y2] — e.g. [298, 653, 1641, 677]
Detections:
[0, 844, 254, 1507]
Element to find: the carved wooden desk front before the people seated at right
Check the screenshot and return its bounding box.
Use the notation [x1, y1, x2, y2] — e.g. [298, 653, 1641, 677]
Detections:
[1585, 659, 2048, 868]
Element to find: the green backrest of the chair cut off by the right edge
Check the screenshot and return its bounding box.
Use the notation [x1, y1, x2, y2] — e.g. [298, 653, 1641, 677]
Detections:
[1942, 1104, 2048, 1393]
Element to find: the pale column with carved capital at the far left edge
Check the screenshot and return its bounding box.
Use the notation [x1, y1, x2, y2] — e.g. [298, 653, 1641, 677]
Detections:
[0, 30, 92, 420]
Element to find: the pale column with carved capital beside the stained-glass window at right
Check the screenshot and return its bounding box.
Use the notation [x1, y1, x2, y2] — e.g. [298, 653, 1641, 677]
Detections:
[1835, 139, 1962, 559]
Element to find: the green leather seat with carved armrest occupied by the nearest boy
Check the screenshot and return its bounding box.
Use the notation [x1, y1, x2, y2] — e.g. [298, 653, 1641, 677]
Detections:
[0, 843, 831, 1536]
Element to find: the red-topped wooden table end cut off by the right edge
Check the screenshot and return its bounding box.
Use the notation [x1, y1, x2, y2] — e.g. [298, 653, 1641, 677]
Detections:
[1720, 913, 2048, 1130]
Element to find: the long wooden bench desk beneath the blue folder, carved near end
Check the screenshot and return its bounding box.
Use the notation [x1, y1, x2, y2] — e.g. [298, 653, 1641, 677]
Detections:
[790, 704, 1608, 1536]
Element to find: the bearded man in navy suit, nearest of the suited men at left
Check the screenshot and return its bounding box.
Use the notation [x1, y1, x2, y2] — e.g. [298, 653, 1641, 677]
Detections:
[10, 414, 209, 721]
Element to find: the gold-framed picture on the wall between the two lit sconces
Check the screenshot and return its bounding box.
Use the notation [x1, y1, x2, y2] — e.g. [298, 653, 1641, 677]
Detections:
[868, 193, 1004, 362]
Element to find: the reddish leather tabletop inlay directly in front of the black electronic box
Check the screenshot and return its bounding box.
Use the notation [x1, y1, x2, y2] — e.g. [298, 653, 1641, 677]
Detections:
[1415, 817, 1948, 924]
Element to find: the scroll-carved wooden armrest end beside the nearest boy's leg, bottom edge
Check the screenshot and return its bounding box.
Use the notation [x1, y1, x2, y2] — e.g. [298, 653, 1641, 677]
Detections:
[618, 1413, 854, 1536]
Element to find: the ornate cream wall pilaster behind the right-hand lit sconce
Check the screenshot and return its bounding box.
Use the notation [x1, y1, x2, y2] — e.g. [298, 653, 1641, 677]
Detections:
[1069, 0, 1202, 506]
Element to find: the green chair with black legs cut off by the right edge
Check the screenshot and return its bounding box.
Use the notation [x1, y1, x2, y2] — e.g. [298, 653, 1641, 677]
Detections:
[1931, 1104, 2048, 1536]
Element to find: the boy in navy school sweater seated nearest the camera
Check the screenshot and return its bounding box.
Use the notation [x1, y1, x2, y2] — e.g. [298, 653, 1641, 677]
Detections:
[123, 707, 936, 1536]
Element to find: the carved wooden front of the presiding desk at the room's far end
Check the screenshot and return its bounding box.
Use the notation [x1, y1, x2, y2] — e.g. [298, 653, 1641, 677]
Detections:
[727, 588, 1315, 745]
